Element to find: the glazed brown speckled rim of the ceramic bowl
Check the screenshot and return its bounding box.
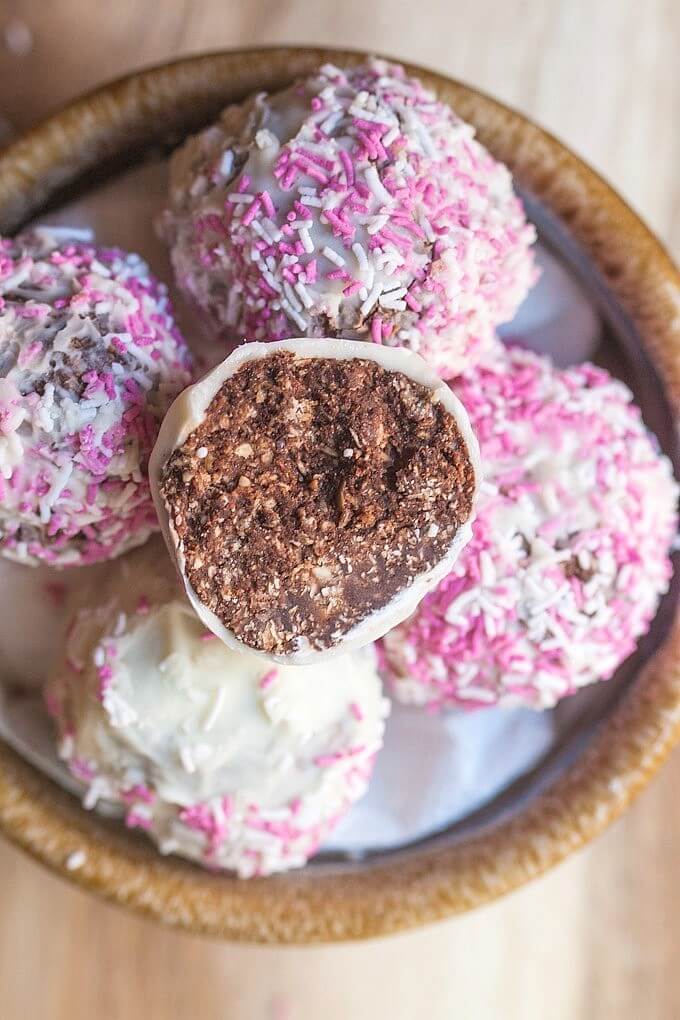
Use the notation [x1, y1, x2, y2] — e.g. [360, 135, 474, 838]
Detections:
[0, 47, 680, 944]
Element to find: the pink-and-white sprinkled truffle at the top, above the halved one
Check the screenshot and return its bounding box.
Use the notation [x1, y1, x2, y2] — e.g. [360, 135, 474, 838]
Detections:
[161, 60, 535, 377]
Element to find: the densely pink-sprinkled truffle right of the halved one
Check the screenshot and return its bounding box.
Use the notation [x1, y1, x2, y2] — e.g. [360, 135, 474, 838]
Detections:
[383, 349, 678, 710]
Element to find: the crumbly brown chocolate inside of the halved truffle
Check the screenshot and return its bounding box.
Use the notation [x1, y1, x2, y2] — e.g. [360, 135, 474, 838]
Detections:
[161, 352, 475, 655]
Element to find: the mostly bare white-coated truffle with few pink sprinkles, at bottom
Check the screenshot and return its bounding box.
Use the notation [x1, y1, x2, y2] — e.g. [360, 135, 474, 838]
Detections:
[47, 543, 388, 878]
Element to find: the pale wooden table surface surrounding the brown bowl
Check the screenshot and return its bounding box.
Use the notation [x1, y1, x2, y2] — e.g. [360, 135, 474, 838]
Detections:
[0, 0, 680, 1020]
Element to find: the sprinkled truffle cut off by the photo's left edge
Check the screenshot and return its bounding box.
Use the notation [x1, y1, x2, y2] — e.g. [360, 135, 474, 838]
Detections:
[0, 227, 190, 567]
